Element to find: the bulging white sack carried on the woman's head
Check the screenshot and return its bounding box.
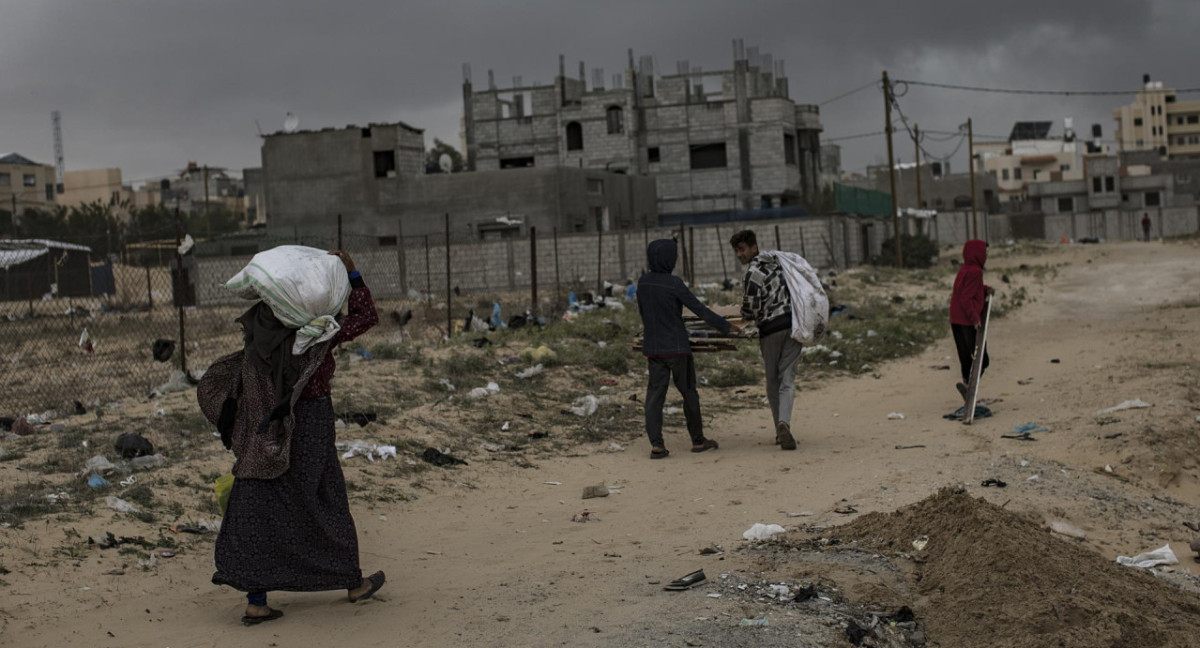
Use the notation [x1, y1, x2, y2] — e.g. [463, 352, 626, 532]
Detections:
[224, 245, 350, 355]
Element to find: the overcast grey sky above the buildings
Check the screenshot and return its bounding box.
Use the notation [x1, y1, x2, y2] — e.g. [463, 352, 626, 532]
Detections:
[0, 0, 1200, 181]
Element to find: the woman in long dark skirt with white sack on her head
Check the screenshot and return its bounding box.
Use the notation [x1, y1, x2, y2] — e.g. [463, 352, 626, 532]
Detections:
[197, 246, 384, 625]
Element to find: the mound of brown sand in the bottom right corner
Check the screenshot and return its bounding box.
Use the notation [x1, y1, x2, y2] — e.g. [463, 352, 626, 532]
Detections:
[826, 490, 1200, 648]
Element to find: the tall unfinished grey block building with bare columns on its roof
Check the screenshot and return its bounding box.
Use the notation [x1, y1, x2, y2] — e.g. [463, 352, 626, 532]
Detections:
[463, 41, 821, 223]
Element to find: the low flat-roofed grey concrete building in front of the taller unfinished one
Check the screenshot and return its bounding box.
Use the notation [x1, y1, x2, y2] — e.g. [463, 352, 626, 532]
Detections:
[258, 122, 655, 245]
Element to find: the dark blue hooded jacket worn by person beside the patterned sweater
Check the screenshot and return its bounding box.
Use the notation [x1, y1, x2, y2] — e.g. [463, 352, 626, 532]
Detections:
[637, 239, 730, 358]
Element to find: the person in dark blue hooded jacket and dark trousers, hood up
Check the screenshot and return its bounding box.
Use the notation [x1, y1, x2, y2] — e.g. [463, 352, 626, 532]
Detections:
[637, 239, 736, 460]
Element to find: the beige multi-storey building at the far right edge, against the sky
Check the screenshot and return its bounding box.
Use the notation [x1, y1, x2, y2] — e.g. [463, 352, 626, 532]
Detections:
[1112, 74, 1200, 158]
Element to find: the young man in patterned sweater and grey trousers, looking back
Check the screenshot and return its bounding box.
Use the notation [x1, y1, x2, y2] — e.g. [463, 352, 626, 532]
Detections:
[730, 229, 802, 450]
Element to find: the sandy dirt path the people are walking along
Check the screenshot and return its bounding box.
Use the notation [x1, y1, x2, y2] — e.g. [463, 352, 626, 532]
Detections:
[0, 244, 1200, 648]
